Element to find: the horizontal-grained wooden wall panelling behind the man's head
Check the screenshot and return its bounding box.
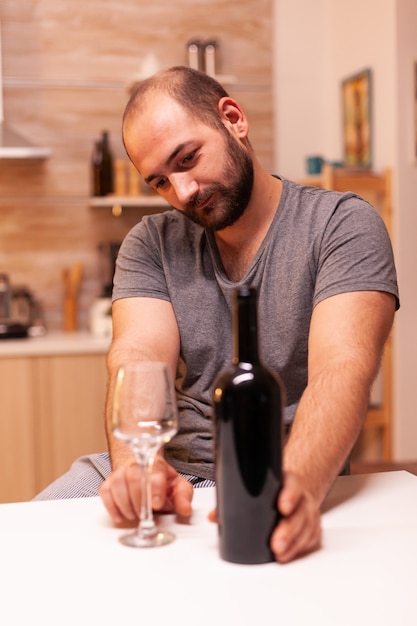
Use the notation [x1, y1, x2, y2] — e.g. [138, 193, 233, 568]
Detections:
[0, 0, 273, 330]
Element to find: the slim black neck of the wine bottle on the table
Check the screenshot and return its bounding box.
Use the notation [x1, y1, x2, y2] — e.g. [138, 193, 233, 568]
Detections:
[233, 287, 259, 364]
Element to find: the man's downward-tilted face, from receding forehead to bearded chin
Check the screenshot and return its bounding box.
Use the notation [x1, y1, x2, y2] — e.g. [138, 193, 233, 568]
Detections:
[124, 96, 253, 230]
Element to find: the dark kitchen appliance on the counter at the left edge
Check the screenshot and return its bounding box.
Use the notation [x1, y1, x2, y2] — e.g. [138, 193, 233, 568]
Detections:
[0, 273, 46, 339]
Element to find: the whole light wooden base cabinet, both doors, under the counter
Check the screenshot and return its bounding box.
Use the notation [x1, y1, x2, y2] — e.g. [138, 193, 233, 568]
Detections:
[0, 354, 107, 502]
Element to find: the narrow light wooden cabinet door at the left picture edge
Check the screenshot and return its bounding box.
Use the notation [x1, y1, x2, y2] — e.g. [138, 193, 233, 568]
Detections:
[0, 358, 37, 502]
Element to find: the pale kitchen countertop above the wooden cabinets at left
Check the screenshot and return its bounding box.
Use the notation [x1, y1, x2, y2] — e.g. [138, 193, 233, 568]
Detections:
[0, 331, 111, 358]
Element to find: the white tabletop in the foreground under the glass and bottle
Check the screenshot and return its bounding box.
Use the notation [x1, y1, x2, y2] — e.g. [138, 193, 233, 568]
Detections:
[0, 471, 417, 626]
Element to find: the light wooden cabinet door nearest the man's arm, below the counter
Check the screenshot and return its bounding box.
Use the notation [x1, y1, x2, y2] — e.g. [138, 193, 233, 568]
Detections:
[35, 355, 107, 491]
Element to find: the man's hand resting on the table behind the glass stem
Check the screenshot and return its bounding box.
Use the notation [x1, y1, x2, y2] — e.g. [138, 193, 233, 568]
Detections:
[100, 455, 193, 524]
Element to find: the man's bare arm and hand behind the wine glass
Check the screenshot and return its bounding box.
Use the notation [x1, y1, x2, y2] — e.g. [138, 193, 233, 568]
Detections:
[100, 298, 192, 522]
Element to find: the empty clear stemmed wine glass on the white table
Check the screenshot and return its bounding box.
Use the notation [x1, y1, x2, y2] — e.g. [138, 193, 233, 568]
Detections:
[112, 361, 178, 548]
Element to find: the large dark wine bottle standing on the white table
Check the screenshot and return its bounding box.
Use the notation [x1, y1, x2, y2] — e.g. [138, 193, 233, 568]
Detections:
[213, 287, 285, 564]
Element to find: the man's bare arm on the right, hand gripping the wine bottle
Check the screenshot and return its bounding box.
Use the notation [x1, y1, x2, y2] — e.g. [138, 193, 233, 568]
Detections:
[271, 291, 395, 561]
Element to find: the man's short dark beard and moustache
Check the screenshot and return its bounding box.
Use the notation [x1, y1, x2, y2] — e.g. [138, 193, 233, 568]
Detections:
[183, 129, 254, 231]
